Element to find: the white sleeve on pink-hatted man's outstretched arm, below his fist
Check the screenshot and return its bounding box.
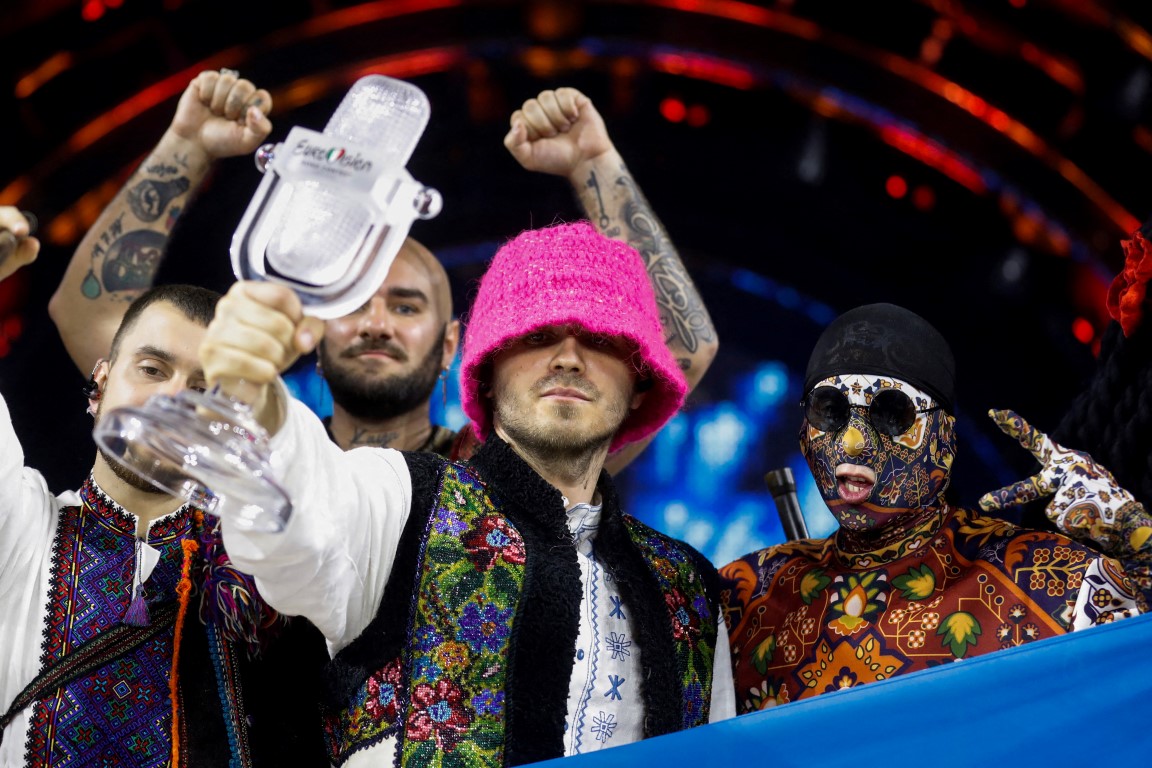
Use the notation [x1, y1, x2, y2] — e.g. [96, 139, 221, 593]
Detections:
[222, 383, 412, 654]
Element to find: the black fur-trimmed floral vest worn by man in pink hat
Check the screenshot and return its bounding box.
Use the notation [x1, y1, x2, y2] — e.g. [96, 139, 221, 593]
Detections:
[325, 435, 718, 766]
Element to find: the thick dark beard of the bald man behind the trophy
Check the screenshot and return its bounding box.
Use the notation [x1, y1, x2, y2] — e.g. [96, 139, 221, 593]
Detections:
[319, 326, 448, 421]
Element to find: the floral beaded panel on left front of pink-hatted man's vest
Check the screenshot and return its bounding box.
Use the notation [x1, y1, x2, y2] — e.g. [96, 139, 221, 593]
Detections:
[401, 465, 526, 768]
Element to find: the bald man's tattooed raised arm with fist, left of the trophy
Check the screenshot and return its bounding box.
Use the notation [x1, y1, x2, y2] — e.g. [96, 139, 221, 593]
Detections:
[48, 69, 272, 375]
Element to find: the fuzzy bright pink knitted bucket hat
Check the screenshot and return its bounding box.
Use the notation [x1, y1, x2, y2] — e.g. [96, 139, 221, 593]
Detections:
[460, 221, 688, 451]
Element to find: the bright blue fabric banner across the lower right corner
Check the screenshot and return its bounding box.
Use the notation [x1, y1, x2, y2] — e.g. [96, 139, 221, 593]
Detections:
[537, 615, 1152, 768]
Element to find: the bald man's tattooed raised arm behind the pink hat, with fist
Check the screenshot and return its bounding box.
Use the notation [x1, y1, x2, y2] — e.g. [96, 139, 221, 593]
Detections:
[505, 88, 720, 473]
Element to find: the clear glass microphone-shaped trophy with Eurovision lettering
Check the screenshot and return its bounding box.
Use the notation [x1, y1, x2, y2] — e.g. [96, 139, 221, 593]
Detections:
[92, 75, 441, 532]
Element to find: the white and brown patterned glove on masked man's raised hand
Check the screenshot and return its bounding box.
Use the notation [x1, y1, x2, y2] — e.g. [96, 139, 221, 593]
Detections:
[979, 411, 1152, 561]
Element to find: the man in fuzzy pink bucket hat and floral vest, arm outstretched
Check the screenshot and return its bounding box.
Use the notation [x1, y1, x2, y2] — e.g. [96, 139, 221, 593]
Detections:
[200, 222, 735, 767]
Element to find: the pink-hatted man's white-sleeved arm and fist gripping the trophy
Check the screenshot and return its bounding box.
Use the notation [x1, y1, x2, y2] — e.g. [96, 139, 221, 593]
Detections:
[199, 281, 411, 651]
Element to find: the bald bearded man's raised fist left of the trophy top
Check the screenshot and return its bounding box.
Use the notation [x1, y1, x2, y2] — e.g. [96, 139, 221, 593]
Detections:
[168, 69, 272, 160]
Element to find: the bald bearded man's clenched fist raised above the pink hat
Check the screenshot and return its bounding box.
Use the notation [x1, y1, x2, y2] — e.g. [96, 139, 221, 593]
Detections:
[505, 88, 615, 176]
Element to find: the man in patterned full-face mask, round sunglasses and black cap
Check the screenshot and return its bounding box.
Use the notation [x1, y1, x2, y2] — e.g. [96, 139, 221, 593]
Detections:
[720, 304, 1146, 713]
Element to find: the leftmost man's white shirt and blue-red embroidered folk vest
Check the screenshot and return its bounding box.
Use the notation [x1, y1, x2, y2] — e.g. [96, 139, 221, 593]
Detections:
[0, 400, 327, 768]
